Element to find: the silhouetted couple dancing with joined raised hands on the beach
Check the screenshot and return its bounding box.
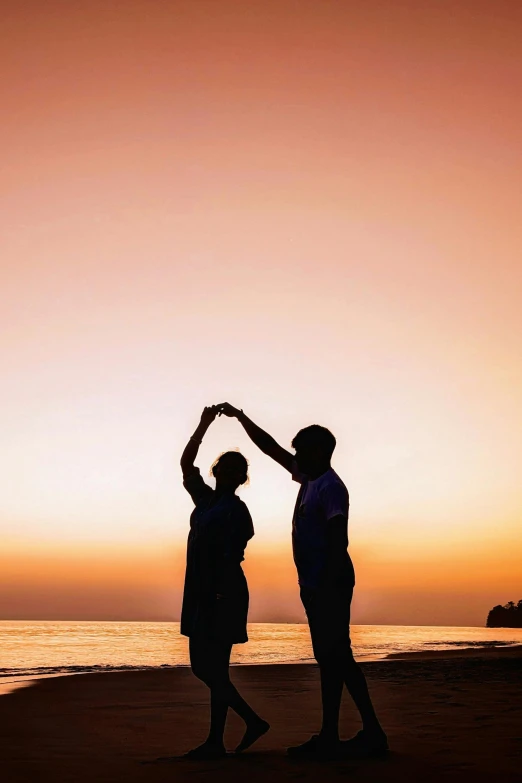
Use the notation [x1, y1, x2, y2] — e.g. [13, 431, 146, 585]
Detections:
[181, 402, 388, 760]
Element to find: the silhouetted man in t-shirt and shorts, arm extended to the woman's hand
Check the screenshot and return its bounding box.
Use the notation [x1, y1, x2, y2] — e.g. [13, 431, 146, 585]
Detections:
[218, 403, 388, 758]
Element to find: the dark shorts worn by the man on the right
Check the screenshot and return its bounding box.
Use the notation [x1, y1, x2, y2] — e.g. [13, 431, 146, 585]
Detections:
[301, 585, 353, 663]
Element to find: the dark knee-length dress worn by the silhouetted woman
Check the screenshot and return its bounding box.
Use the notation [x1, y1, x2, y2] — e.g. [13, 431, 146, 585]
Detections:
[181, 468, 254, 644]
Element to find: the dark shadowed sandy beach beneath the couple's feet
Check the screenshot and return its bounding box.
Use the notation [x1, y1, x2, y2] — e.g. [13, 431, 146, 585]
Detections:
[0, 647, 522, 783]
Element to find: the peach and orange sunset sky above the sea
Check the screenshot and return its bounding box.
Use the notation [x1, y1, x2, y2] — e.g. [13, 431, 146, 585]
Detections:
[0, 0, 522, 625]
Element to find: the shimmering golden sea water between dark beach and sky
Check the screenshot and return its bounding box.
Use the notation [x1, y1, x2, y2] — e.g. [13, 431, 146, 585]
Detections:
[0, 621, 522, 684]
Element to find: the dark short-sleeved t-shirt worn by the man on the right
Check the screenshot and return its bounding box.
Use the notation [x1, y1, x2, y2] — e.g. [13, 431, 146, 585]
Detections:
[292, 462, 354, 588]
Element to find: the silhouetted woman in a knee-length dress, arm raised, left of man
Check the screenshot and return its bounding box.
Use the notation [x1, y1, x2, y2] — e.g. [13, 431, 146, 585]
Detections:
[181, 406, 270, 759]
